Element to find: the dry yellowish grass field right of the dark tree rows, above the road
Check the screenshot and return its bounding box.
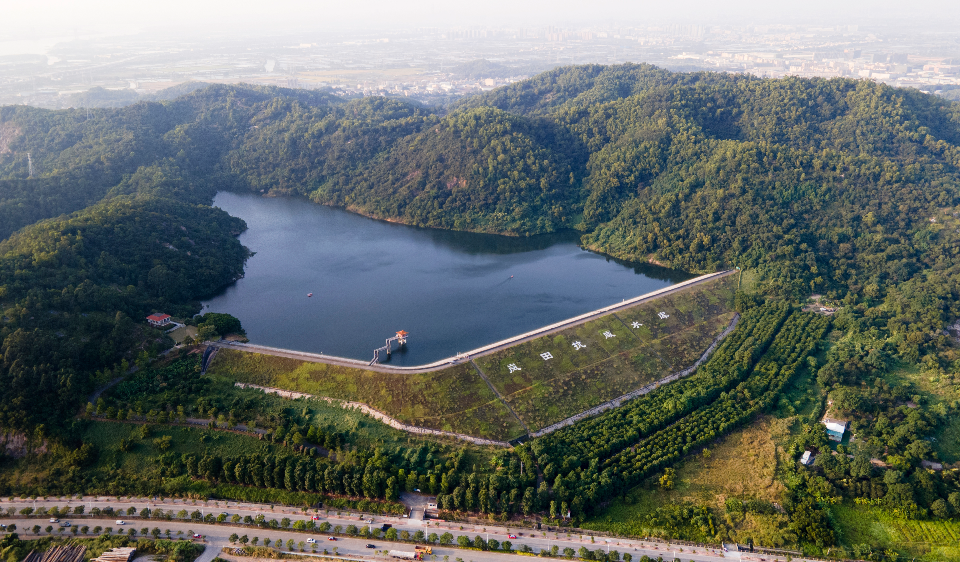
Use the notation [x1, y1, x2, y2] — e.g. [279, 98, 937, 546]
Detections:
[583, 417, 790, 547]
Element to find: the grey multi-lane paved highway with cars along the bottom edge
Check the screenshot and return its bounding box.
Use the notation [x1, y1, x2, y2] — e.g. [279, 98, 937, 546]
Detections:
[0, 497, 800, 562]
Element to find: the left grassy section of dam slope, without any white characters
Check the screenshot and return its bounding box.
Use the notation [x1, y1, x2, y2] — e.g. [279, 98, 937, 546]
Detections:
[209, 349, 523, 439]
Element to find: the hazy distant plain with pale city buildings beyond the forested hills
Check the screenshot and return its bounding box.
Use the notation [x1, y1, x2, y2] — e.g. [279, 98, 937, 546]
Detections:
[0, 18, 960, 109]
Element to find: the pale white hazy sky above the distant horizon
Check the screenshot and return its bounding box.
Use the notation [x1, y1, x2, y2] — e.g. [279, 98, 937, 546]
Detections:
[7, 0, 960, 41]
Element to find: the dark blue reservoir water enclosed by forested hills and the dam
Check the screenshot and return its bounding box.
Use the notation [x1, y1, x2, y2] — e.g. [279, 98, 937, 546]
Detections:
[204, 192, 692, 365]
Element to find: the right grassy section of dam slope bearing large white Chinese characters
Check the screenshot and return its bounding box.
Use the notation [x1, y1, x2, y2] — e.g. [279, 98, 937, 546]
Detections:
[476, 275, 736, 430]
